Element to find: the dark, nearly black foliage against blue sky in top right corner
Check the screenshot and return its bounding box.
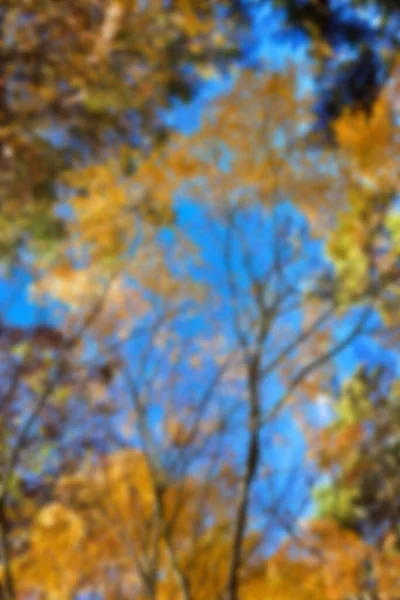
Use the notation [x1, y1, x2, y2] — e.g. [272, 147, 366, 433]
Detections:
[274, 0, 400, 136]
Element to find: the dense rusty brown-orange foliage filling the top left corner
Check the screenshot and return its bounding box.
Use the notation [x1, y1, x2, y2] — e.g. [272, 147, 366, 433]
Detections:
[0, 0, 256, 256]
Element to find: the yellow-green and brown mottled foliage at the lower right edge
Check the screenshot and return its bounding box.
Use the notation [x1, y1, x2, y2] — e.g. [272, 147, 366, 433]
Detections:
[316, 368, 400, 547]
